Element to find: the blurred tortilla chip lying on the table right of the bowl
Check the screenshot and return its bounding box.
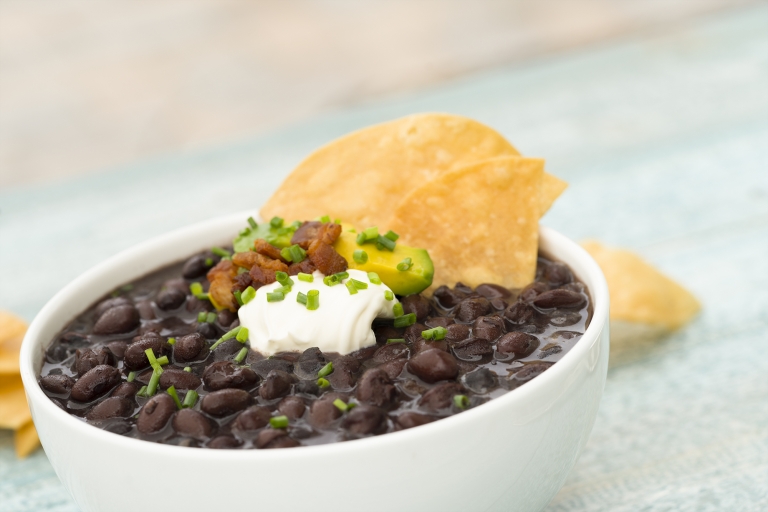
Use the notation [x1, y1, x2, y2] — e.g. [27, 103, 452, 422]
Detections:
[582, 240, 701, 330]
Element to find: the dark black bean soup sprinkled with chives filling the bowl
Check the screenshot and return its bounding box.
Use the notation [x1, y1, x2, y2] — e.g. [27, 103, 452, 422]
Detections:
[40, 253, 592, 448]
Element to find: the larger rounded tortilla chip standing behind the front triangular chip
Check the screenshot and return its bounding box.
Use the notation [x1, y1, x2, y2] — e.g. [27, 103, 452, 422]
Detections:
[261, 114, 562, 228]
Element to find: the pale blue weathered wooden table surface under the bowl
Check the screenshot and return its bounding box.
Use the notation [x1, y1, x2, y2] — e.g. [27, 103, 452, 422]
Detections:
[0, 4, 768, 512]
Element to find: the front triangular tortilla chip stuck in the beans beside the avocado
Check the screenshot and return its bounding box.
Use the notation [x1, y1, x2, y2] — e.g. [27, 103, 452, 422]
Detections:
[385, 156, 544, 289]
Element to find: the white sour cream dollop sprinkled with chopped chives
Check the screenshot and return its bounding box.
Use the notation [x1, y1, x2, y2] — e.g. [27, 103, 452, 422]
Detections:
[238, 269, 397, 355]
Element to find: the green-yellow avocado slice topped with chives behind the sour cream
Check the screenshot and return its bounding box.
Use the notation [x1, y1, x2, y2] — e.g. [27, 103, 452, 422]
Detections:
[333, 230, 435, 295]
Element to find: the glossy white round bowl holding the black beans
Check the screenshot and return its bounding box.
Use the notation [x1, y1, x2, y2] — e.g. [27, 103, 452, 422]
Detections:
[21, 212, 608, 512]
